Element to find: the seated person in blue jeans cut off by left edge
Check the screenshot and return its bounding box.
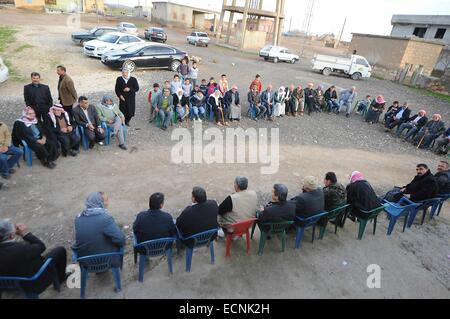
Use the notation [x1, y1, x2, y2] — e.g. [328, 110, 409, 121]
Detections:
[0, 122, 23, 179]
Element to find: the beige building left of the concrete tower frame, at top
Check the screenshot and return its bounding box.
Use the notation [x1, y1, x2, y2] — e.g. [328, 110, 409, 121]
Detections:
[151, 1, 220, 30]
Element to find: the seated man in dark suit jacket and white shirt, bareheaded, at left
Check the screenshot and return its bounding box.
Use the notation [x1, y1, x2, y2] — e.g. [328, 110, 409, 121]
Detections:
[73, 96, 105, 148]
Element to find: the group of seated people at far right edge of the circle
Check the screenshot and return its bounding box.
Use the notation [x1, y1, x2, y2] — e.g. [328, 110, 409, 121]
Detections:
[357, 95, 450, 155]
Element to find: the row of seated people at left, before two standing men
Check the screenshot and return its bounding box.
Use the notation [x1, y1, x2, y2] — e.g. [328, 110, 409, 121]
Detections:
[0, 96, 127, 171]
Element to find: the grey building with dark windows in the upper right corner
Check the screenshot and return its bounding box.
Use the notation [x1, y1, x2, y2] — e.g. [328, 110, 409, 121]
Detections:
[391, 14, 450, 73]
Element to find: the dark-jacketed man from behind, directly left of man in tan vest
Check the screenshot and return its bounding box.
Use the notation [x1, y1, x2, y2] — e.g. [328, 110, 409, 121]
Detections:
[176, 187, 219, 247]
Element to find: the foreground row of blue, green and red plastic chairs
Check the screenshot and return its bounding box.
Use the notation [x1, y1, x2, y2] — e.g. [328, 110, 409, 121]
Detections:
[0, 194, 450, 298]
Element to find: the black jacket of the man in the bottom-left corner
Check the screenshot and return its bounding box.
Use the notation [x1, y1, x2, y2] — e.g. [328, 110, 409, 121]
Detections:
[0, 233, 51, 293]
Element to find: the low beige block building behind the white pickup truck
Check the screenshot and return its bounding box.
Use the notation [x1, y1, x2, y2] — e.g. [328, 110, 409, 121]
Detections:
[350, 33, 444, 75]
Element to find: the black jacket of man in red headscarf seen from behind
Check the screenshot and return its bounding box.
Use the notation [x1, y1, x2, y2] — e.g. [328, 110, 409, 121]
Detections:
[347, 180, 381, 212]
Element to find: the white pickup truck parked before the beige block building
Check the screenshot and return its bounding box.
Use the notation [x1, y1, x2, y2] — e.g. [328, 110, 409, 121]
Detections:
[311, 54, 372, 80]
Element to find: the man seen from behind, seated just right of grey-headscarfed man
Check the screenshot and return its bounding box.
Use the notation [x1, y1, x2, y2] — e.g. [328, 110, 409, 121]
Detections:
[133, 193, 177, 243]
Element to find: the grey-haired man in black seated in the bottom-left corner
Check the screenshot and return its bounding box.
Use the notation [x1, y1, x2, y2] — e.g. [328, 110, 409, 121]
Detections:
[0, 219, 67, 294]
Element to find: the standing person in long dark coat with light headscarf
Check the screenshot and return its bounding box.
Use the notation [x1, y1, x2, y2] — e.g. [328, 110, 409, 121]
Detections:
[115, 69, 139, 126]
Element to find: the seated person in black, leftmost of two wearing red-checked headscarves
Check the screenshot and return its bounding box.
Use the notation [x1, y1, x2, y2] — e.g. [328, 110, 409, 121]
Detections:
[12, 106, 59, 168]
